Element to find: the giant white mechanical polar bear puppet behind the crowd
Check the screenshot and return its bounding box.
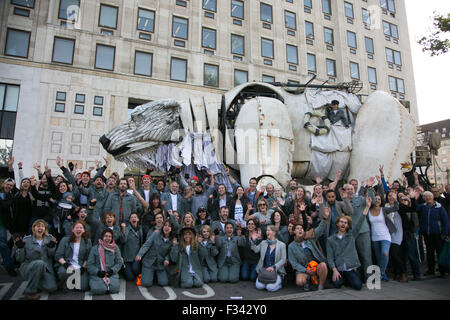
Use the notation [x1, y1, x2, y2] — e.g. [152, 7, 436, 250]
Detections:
[100, 82, 416, 189]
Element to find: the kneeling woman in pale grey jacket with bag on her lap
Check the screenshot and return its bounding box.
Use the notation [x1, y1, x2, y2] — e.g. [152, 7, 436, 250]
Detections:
[251, 225, 286, 292]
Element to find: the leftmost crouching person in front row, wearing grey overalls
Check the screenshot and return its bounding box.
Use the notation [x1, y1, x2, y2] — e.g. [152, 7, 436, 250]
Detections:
[15, 219, 58, 300]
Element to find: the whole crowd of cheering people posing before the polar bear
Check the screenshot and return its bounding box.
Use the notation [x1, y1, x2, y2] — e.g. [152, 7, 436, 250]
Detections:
[0, 157, 450, 299]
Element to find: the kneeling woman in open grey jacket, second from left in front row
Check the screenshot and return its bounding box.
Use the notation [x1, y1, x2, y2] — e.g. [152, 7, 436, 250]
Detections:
[55, 220, 92, 291]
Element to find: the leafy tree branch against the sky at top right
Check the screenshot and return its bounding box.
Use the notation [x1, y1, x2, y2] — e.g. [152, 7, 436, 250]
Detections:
[417, 12, 450, 57]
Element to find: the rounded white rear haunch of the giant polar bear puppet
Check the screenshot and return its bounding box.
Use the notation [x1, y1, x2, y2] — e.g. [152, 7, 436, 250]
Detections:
[349, 91, 417, 182]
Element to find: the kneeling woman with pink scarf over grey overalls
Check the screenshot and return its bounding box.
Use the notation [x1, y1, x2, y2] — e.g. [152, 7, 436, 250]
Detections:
[87, 229, 123, 295]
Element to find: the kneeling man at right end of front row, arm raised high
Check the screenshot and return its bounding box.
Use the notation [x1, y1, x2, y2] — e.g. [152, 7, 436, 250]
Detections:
[327, 197, 372, 290]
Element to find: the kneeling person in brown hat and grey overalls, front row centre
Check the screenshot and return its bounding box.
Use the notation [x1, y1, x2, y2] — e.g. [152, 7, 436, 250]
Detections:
[170, 227, 203, 289]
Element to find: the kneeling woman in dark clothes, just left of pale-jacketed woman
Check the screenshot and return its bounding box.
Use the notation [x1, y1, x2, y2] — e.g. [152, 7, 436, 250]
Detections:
[239, 219, 262, 282]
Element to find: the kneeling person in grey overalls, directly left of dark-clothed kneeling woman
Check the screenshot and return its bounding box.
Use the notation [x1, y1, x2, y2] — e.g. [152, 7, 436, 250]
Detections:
[216, 222, 245, 283]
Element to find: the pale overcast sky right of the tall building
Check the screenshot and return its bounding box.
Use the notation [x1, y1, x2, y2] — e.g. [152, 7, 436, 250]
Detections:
[405, 0, 450, 125]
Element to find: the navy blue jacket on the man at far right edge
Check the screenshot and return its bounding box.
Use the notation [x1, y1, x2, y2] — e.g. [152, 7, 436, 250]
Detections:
[417, 202, 449, 236]
